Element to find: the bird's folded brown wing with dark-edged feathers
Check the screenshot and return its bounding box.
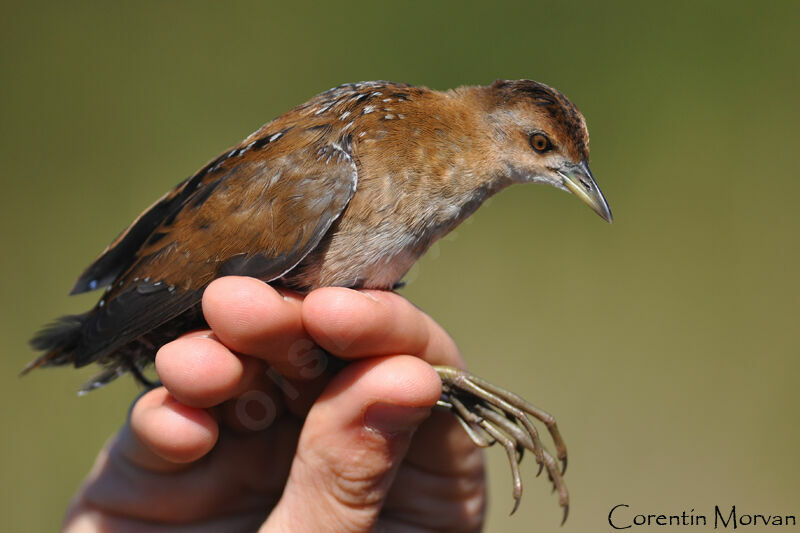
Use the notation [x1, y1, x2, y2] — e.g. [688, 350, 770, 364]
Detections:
[74, 131, 357, 366]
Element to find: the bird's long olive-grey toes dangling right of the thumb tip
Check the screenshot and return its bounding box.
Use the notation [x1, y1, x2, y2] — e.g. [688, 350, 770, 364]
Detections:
[434, 366, 569, 523]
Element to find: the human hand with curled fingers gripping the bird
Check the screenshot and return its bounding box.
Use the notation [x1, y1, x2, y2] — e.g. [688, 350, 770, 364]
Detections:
[63, 277, 486, 533]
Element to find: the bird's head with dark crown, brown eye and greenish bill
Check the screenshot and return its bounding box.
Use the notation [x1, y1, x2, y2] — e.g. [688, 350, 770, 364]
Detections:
[488, 80, 612, 222]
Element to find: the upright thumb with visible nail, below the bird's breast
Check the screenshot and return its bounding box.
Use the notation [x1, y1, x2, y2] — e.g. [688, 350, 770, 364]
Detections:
[261, 356, 441, 533]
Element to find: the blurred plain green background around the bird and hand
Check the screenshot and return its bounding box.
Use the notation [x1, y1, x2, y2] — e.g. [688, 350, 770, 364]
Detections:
[0, 1, 800, 532]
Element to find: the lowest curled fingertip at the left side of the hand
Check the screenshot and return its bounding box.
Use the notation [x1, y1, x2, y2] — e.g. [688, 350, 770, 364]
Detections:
[126, 387, 219, 471]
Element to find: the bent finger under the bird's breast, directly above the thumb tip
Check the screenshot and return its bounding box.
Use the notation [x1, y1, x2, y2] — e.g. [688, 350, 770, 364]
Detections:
[302, 287, 463, 367]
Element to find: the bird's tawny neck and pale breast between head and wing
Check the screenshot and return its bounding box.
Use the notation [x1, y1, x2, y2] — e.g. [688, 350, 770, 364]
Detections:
[284, 90, 506, 290]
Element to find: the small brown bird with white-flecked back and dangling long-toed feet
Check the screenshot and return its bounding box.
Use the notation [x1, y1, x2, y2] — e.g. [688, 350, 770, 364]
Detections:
[24, 80, 611, 518]
